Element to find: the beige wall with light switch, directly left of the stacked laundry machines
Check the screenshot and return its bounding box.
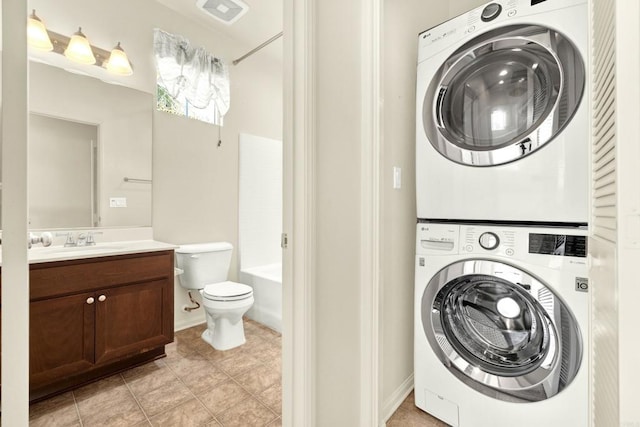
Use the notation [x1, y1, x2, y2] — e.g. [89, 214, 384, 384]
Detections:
[380, 0, 449, 417]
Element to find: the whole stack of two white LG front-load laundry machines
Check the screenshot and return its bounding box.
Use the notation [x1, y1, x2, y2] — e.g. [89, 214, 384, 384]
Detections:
[415, 0, 590, 427]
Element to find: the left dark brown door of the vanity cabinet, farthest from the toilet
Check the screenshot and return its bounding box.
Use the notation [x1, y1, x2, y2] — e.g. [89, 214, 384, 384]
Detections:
[29, 293, 96, 387]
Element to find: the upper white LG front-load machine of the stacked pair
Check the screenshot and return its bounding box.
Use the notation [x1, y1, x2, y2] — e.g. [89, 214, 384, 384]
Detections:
[416, 0, 589, 224]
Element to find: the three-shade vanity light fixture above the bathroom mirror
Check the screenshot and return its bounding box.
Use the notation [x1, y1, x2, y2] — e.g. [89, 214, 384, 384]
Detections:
[27, 10, 133, 76]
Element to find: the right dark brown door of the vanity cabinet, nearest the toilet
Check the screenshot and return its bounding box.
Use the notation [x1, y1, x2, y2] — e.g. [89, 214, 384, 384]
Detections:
[95, 279, 173, 363]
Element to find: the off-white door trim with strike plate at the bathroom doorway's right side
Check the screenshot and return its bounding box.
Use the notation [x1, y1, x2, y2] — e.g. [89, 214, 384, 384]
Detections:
[282, 0, 316, 427]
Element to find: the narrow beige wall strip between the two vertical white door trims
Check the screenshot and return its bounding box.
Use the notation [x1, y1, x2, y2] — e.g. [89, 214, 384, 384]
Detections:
[313, 1, 363, 426]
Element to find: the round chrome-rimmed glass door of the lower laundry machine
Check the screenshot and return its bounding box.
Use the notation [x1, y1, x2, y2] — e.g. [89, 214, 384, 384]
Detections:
[421, 259, 583, 402]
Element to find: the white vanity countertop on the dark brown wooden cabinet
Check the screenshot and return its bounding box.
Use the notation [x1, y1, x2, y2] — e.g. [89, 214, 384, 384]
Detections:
[0, 240, 178, 265]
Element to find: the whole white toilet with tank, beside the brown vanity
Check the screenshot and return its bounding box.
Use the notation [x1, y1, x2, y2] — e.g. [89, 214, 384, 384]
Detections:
[175, 242, 253, 350]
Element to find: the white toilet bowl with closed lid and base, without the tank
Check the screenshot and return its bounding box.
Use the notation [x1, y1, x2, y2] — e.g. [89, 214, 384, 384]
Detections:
[200, 281, 253, 350]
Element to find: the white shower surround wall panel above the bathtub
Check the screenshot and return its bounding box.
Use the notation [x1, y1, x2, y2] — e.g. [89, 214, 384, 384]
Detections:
[238, 133, 282, 270]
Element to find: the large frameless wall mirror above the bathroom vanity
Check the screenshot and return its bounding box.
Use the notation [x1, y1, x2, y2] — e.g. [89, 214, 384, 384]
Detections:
[23, 62, 153, 229]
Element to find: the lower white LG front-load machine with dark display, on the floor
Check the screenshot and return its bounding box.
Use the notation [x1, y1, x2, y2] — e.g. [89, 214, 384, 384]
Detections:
[415, 223, 590, 427]
